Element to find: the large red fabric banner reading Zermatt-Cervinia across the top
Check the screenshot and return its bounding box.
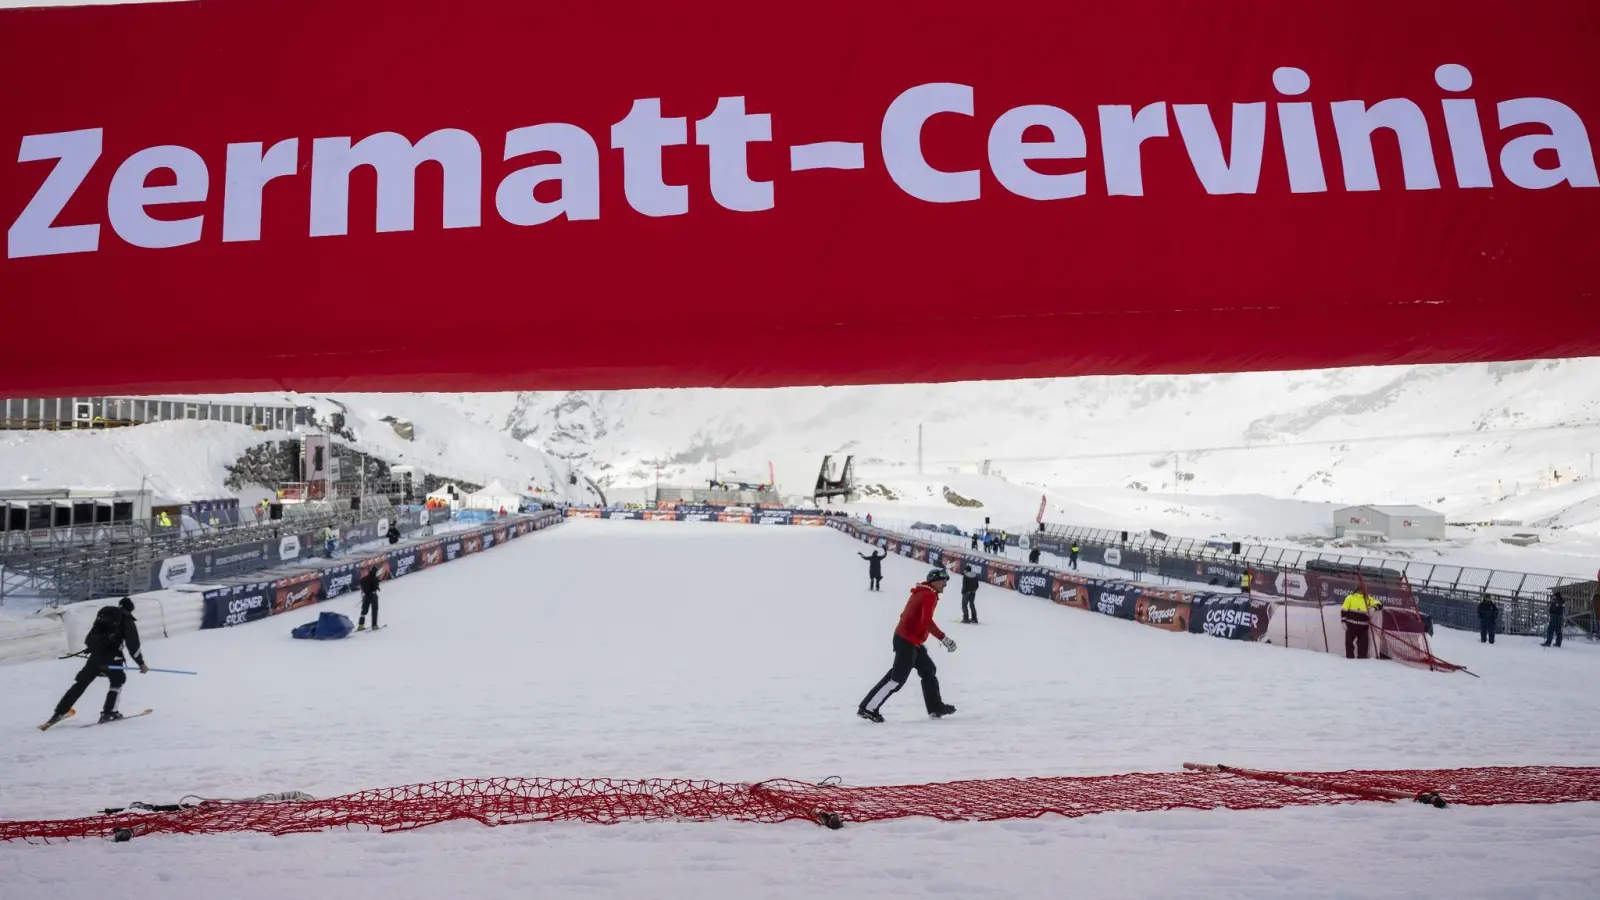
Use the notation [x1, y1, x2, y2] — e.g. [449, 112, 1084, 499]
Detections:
[0, 0, 1600, 394]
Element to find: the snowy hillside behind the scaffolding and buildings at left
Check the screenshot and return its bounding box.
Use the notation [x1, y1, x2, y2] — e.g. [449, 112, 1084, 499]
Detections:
[0, 394, 592, 501]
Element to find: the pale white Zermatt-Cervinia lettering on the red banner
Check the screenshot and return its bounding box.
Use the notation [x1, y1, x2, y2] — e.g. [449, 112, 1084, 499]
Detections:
[6, 62, 1600, 259]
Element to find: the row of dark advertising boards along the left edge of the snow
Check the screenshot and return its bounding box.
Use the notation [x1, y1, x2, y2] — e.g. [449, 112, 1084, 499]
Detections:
[200, 512, 562, 629]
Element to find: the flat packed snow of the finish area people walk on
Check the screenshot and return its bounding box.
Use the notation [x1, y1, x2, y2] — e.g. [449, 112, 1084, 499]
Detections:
[0, 522, 1600, 900]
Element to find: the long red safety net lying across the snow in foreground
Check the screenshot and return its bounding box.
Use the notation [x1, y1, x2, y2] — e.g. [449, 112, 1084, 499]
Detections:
[0, 767, 1600, 842]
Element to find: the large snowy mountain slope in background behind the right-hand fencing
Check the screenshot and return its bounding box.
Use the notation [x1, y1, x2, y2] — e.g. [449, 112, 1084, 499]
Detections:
[428, 359, 1600, 525]
